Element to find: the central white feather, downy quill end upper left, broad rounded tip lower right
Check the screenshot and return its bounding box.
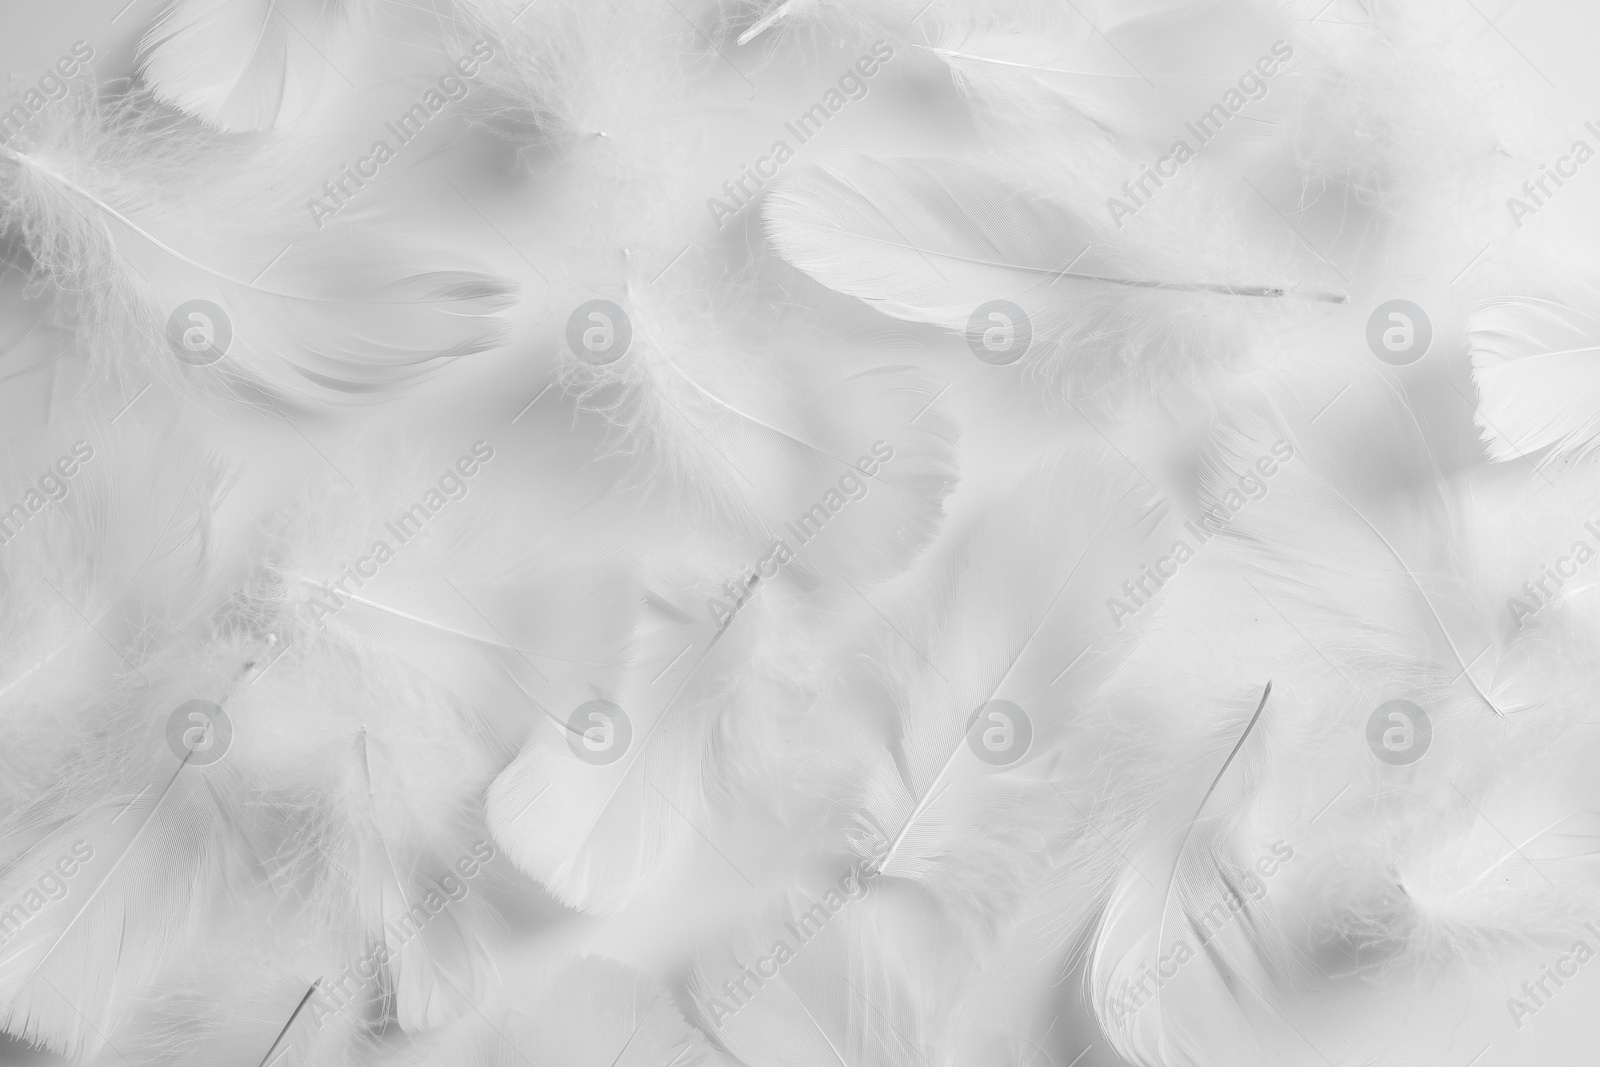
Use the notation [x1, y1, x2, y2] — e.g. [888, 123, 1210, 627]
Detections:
[566, 282, 957, 584]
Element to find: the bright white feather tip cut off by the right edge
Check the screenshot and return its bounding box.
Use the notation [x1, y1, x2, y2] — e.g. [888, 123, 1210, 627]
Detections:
[1467, 285, 1600, 462]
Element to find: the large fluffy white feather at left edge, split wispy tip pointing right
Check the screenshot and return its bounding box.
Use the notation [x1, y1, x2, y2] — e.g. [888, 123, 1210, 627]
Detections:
[0, 86, 514, 405]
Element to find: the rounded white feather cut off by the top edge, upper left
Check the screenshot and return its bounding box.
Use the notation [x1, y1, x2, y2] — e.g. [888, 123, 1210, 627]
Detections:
[139, 0, 368, 133]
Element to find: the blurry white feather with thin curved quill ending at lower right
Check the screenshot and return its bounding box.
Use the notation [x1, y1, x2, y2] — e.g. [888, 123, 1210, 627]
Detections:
[1202, 373, 1504, 715]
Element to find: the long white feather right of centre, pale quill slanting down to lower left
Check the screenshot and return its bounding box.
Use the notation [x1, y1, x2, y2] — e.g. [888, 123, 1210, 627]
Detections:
[851, 453, 1173, 926]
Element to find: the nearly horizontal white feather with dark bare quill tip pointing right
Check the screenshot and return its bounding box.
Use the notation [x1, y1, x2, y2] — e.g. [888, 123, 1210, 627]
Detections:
[763, 157, 1344, 412]
